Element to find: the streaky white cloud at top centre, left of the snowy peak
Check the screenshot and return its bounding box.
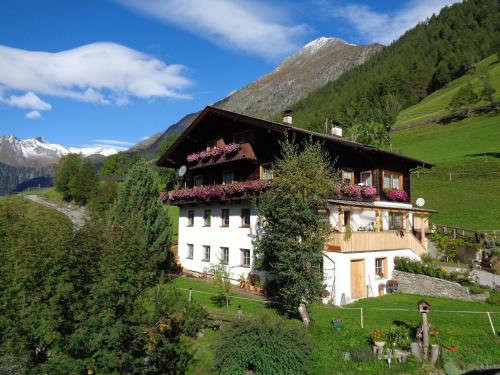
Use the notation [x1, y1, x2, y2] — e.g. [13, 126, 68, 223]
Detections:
[116, 0, 308, 59]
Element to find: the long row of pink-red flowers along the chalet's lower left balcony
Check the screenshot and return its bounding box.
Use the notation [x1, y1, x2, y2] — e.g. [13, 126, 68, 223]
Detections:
[160, 180, 270, 202]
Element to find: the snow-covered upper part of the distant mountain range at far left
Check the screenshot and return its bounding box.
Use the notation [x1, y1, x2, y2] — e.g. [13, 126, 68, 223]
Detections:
[0, 135, 116, 167]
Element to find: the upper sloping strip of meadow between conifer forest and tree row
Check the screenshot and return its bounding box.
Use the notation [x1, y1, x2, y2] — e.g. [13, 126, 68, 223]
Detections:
[395, 55, 500, 128]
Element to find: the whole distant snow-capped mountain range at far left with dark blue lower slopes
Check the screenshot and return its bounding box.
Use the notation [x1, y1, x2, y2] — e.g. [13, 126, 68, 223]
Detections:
[0, 135, 116, 195]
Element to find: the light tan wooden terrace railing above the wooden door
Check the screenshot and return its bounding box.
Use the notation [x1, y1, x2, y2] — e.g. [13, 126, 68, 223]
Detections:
[325, 231, 426, 256]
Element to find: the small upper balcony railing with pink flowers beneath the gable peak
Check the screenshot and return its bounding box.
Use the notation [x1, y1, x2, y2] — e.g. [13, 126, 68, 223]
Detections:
[187, 143, 257, 169]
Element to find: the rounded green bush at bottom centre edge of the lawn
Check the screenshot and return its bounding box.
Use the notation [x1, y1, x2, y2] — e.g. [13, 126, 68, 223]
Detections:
[215, 315, 313, 375]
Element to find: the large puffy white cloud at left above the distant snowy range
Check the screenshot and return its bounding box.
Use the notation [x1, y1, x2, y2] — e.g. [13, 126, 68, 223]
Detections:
[0, 42, 191, 114]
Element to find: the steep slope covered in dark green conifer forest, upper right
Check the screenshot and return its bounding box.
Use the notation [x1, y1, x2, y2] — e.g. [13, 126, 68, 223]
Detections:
[291, 0, 500, 136]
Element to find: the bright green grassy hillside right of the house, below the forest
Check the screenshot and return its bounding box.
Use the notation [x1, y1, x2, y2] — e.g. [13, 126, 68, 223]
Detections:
[392, 57, 500, 230]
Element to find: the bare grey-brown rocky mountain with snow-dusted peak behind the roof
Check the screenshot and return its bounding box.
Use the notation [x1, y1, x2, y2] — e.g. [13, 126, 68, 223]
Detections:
[130, 37, 383, 157]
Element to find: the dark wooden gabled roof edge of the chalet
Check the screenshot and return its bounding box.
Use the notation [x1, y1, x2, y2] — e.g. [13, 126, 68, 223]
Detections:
[156, 106, 433, 168]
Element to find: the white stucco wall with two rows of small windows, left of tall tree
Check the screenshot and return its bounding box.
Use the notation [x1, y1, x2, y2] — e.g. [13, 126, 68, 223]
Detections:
[178, 202, 257, 281]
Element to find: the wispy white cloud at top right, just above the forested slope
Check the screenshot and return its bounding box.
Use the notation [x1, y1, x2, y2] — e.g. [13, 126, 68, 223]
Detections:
[320, 0, 459, 45]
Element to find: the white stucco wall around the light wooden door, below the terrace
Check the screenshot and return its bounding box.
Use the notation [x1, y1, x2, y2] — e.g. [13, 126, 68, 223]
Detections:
[323, 249, 419, 305]
